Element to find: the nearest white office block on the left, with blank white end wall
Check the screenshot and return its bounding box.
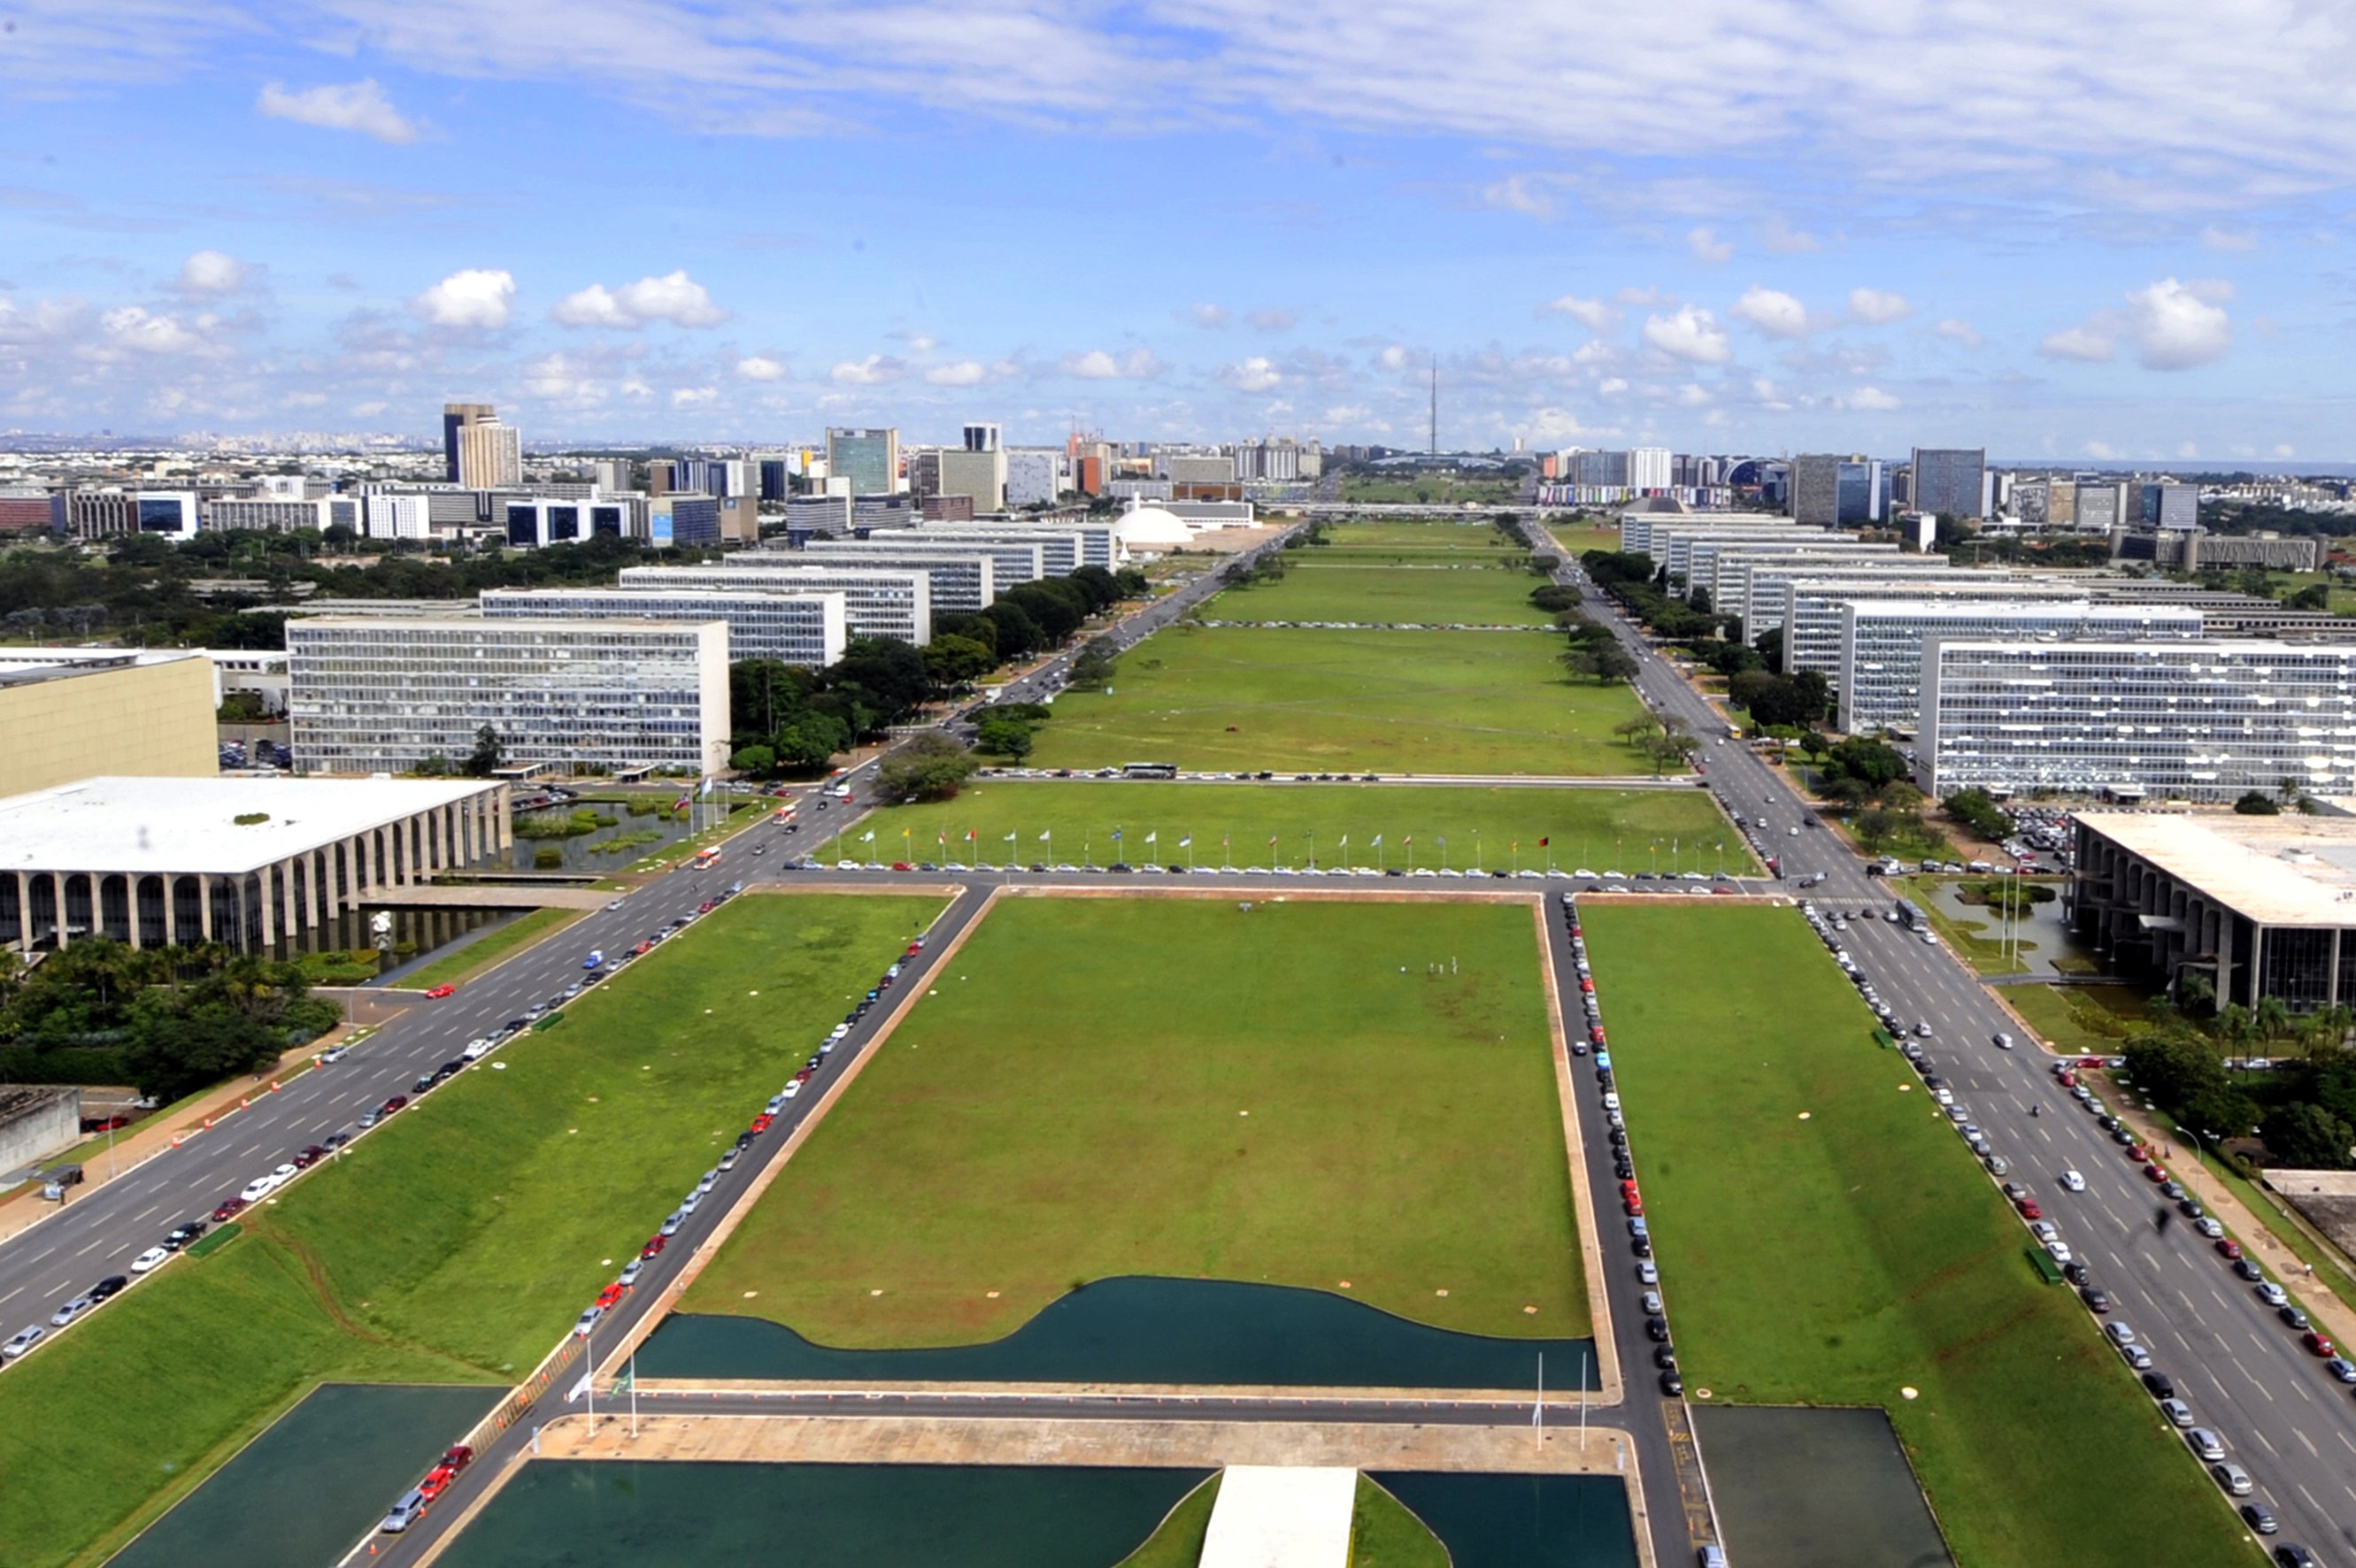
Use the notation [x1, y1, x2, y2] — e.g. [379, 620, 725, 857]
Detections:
[288, 617, 728, 774]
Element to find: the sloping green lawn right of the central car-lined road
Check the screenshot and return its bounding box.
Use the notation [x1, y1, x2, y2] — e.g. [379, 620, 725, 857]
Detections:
[1588, 906, 2248, 1568]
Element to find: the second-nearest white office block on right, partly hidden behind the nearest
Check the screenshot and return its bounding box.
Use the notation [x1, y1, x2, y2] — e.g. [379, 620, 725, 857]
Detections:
[1837, 598, 2200, 734]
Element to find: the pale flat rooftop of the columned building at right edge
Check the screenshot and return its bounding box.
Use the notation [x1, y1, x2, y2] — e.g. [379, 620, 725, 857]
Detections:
[2078, 812, 2356, 926]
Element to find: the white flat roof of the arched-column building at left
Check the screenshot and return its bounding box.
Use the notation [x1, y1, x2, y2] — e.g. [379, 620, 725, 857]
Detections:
[0, 777, 499, 876]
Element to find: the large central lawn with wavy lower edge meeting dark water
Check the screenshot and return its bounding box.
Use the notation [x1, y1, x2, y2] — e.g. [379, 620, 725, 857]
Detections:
[683, 899, 1588, 1347]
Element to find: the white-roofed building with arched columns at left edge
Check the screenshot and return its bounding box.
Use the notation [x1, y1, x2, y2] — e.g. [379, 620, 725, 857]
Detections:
[0, 777, 513, 954]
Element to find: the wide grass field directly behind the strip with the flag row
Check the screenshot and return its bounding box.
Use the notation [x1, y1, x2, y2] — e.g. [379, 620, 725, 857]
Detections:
[1032, 626, 1652, 774]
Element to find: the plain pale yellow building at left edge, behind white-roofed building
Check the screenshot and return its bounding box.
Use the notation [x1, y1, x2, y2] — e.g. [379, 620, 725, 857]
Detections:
[0, 648, 221, 796]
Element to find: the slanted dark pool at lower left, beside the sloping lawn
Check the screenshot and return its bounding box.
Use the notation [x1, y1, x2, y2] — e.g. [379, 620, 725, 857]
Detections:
[111, 1382, 504, 1568]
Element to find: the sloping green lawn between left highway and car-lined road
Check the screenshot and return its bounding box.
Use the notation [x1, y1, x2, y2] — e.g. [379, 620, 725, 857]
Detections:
[0, 897, 937, 1568]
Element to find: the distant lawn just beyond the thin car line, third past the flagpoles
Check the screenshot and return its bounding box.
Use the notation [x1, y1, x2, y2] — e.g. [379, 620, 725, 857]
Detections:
[1202, 562, 1555, 626]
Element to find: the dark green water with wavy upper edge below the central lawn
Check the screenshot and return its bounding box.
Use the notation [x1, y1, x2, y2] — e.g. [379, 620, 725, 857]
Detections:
[638, 1279, 1595, 1389]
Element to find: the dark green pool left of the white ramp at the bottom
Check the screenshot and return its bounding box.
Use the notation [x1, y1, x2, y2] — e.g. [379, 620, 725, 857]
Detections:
[441, 1460, 1209, 1568]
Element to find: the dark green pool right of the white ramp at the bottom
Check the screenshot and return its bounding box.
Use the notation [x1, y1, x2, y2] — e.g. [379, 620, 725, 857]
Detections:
[1371, 1472, 1637, 1568]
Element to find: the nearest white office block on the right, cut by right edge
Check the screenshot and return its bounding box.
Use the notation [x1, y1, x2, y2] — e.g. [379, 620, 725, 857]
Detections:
[1921, 638, 2356, 800]
